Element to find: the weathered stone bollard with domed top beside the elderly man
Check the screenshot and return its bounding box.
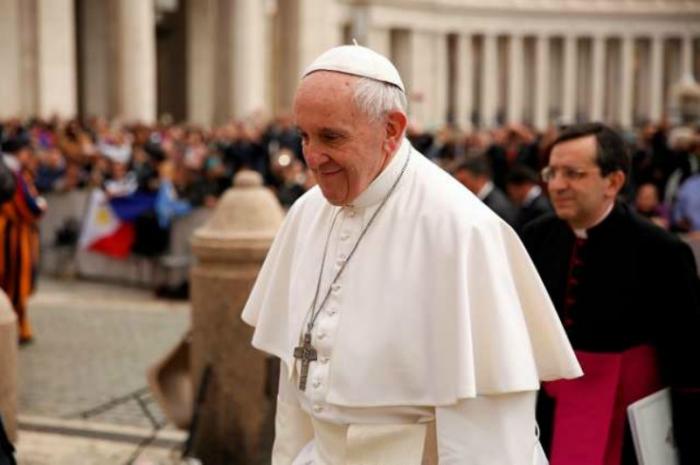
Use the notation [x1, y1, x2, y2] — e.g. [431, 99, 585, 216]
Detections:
[191, 171, 283, 464]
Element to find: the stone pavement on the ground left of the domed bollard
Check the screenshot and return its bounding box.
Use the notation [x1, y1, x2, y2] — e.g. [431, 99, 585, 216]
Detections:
[17, 276, 190, 465]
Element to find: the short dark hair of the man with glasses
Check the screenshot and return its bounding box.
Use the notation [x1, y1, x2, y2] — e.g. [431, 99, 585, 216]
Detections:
[549, 123, 630, 176]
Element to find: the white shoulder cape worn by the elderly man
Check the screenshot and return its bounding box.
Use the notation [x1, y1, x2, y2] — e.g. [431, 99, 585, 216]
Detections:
[243, 145, 582, 407]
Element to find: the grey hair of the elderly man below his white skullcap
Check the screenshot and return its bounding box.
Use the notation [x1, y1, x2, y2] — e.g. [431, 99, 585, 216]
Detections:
[353, 77, 408, 122]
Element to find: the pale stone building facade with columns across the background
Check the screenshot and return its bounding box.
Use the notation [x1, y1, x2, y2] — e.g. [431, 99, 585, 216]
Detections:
[0, 0, 700, 129]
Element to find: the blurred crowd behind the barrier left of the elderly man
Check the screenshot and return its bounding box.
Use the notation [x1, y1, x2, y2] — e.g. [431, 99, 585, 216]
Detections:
[0, 114, 308, 207]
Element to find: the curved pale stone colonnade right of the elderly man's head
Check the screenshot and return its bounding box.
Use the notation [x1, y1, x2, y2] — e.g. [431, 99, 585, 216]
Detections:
[368, 29, 700, 129]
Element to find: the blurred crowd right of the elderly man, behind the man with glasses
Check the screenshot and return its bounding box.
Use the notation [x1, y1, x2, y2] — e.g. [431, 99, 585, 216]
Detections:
[410, 123, 700, 232]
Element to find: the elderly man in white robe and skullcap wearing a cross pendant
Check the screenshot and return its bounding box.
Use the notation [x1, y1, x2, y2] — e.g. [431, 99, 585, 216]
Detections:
[243, 45, 581, 465]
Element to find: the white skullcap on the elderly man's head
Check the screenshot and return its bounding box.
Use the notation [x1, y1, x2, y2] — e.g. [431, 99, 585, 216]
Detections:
[303, 45, 406, 92]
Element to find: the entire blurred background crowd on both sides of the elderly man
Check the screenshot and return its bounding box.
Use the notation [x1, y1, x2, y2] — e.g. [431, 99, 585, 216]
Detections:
[0, 115, 700, 232]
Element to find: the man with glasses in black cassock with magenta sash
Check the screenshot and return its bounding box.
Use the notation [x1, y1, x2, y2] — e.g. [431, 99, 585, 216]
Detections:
[523, 123, 700, 465]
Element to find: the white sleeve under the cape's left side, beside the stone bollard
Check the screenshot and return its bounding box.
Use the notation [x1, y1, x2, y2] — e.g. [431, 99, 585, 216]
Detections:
[272, 363, 314, 465]
